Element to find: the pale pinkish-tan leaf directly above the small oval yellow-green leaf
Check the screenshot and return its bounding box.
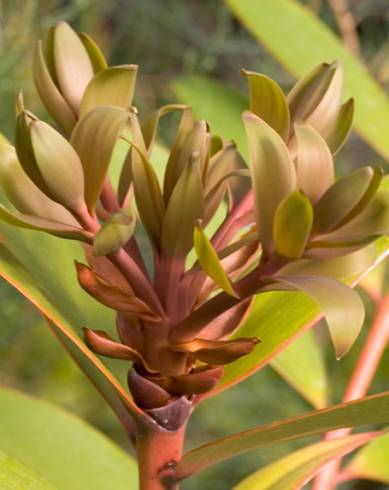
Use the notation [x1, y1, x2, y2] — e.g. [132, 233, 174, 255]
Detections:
[295, 124, 334, 204]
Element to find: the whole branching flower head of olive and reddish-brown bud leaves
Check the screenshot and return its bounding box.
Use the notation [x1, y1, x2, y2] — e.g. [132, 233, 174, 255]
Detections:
[0, 22, 389, 422]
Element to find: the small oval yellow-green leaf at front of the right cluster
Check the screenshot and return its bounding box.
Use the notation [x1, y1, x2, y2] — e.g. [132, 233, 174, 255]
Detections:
[273, 191, 313, 259]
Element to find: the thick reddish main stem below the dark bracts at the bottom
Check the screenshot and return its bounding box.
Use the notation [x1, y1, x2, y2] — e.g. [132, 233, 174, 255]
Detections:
[136, 425, 186, 490]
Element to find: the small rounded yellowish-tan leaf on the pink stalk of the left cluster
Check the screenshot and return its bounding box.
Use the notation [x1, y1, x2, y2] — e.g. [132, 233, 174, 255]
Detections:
[93, 208, 136, 256]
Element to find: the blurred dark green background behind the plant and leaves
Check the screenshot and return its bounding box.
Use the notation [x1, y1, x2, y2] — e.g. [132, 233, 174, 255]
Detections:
[0, 0, 389, 490]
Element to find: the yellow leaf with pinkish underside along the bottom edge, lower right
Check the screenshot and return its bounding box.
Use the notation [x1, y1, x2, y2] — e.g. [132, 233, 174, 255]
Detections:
[234, 433, 376, 490]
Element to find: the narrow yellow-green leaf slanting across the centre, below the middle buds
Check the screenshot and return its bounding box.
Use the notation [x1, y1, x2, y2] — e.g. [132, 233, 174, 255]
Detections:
[193, 225, 237, 298]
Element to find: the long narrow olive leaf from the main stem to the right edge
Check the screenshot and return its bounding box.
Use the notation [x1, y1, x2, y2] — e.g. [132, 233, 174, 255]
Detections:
[175, 392, 389, 478]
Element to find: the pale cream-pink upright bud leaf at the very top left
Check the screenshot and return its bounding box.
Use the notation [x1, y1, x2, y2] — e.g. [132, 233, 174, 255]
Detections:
[52, 21, 93, 114]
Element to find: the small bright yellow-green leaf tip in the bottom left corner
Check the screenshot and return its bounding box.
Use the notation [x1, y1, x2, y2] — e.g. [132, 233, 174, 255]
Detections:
[0, 451, 58, 490]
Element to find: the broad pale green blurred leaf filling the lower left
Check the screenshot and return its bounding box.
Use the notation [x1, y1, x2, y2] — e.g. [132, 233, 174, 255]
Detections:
[0, 388, 137, 490]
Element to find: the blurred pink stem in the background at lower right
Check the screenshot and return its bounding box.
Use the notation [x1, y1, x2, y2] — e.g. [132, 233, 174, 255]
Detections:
[313, 293, 389, 490]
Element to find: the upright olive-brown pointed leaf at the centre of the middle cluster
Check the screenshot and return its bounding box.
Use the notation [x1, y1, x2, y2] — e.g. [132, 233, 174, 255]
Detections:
[161, 152, 204, 257]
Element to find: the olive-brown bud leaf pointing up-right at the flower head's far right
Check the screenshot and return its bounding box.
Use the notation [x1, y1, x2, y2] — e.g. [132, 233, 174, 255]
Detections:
[314, 167, 382, 233]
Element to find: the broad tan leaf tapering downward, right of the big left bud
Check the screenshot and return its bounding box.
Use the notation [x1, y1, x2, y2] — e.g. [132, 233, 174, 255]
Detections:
[70, 107, 129, 211]
